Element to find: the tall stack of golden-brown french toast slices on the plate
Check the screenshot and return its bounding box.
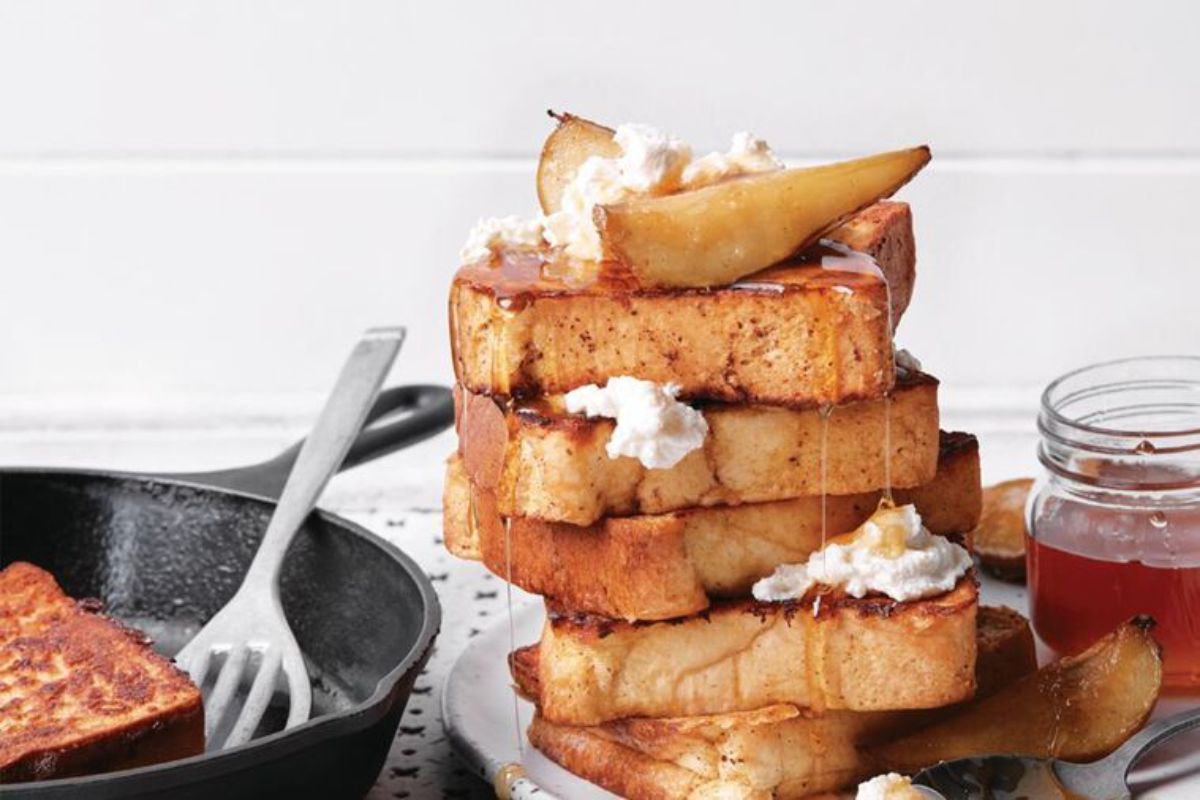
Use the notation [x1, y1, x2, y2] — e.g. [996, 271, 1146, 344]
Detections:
[444, 118, 1003, 798]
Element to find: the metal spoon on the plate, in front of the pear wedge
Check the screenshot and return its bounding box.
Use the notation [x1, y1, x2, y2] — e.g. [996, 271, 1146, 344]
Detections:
[913, 709, 1200, 800]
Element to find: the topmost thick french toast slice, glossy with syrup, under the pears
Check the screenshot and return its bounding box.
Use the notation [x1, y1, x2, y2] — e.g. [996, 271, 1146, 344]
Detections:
[450, 203, 916, 405]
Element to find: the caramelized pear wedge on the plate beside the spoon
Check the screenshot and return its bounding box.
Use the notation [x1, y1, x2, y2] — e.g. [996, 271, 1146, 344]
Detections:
[872, 618, 1163, 772]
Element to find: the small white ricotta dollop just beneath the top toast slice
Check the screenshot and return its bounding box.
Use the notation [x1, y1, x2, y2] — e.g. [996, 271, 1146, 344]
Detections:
[566, 375, 708, 469]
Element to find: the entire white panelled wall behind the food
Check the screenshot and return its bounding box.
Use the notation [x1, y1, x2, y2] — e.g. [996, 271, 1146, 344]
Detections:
[0, 0, 1200, 462]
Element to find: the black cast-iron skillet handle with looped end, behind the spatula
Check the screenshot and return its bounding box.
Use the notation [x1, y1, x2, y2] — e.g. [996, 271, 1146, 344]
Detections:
[161, 385, 454, 499]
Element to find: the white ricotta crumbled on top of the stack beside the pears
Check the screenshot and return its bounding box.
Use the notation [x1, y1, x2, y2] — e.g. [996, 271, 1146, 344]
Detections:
[462, 124, 784, 263]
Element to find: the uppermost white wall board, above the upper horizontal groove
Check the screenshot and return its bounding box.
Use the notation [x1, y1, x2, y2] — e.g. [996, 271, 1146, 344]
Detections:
[0, 0, 1200, 155]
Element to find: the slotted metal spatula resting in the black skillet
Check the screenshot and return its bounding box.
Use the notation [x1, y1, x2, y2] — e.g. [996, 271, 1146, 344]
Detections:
[175, 327, 404, 751]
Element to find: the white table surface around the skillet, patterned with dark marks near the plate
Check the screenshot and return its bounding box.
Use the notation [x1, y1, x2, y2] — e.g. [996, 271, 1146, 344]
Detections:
[0, 410, 1128, 800]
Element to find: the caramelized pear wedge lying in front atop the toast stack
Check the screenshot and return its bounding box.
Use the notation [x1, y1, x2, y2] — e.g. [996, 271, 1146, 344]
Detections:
[595, 146, 930, 287]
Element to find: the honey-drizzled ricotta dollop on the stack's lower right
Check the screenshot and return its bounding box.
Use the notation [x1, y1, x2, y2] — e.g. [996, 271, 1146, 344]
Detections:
[752, 505, 971, 602]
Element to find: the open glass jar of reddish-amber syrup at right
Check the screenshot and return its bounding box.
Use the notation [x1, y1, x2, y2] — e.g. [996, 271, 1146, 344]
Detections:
[1028, 356, 1200, 690]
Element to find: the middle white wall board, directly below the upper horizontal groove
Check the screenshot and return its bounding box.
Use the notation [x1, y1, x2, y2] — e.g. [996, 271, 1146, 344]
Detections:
[0, 160, 1200, 412]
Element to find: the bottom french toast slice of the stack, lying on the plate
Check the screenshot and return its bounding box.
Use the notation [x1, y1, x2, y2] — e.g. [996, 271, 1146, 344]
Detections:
[511, 607, 1037, 800]
